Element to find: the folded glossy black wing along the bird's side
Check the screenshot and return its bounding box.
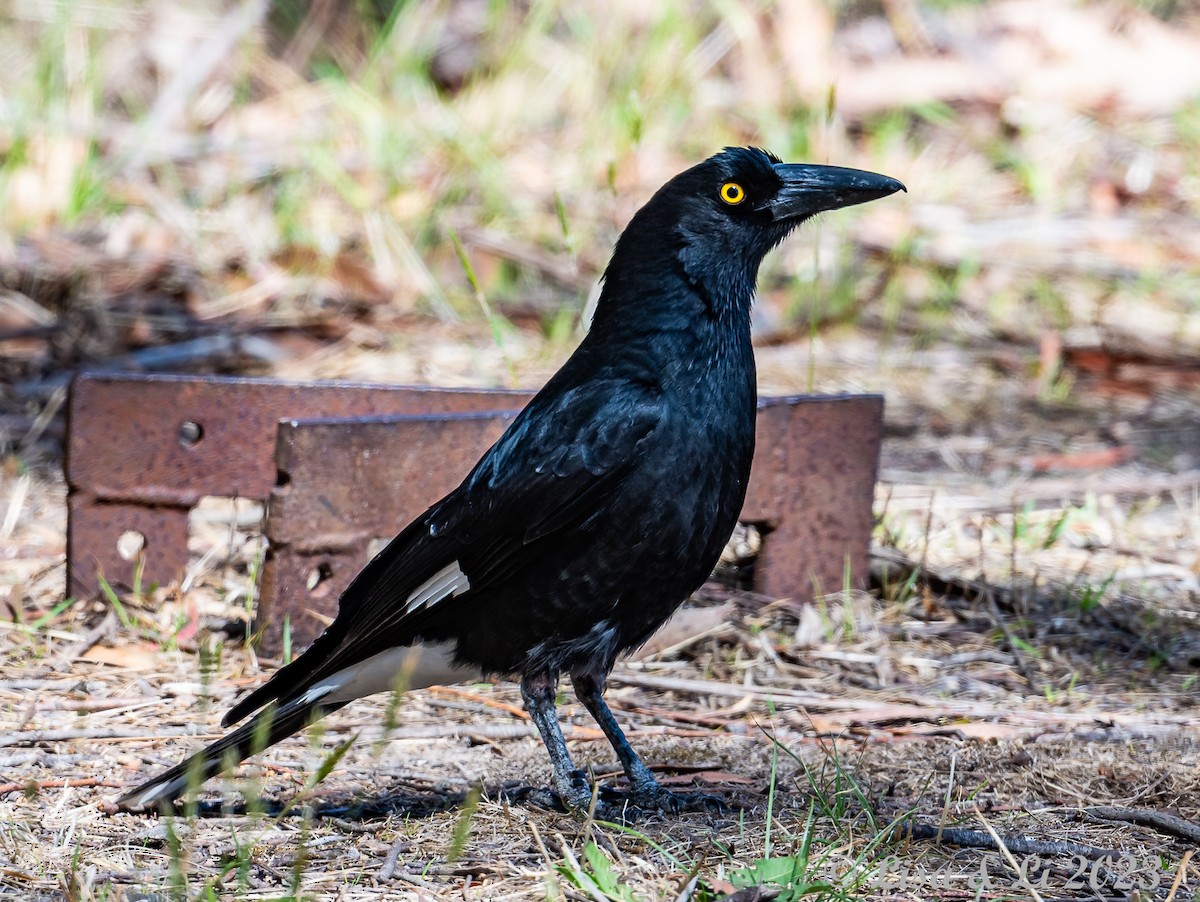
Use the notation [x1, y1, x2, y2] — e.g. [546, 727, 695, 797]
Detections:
[222, 379, 667, 726]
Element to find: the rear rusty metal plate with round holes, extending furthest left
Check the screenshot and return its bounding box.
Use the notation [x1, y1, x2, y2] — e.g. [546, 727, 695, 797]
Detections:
[66, 373, 530, 595]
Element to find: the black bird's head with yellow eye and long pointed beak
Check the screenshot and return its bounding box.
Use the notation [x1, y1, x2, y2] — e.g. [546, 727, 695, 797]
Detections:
[606, 148, 905, 321]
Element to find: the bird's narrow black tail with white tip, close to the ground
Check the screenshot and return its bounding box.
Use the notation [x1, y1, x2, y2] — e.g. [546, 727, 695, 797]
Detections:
[116, 696, 346, 811]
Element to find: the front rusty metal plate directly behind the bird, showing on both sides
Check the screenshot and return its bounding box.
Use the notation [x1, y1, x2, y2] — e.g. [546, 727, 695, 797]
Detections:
[258, 395, 883, 654]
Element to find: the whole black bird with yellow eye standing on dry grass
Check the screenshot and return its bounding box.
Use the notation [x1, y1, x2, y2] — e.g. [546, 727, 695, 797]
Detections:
[118, 148, 904, 810]
